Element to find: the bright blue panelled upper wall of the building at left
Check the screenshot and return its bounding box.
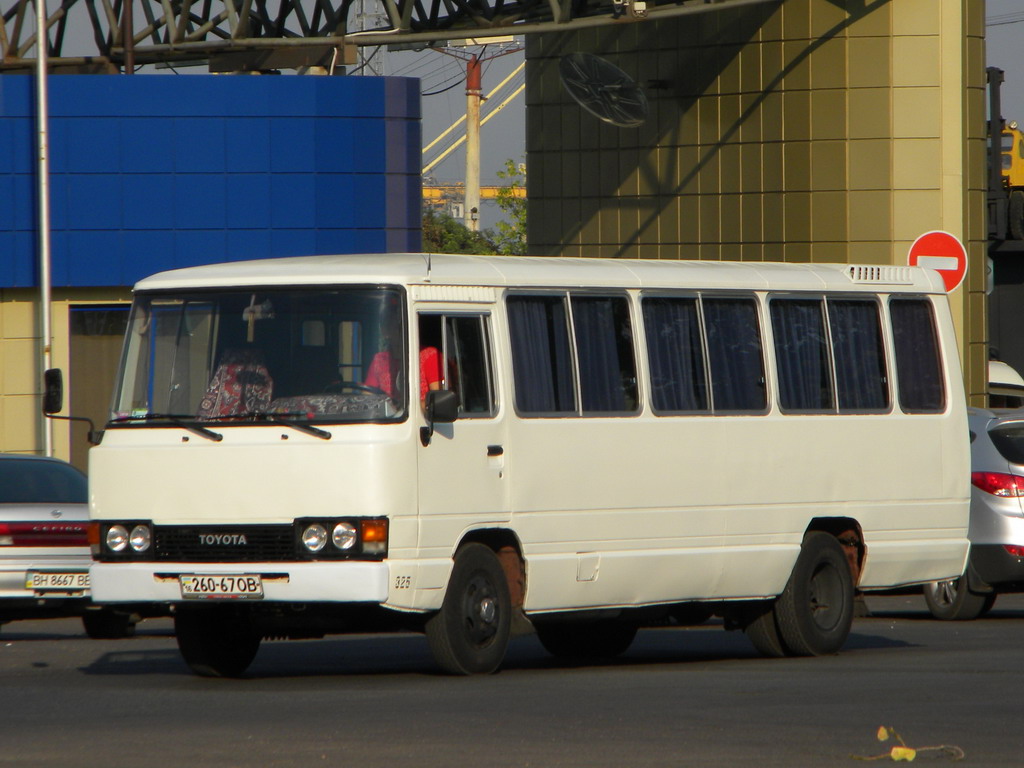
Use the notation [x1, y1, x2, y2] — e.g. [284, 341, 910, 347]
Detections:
[0, 75, 421, 288]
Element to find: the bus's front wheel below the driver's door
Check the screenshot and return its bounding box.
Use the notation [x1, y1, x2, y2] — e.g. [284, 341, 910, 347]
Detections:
[426, 544, 512, 675]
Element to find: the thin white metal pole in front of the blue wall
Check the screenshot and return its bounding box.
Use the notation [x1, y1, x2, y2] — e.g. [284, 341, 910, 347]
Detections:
[36, 0, 53, 456]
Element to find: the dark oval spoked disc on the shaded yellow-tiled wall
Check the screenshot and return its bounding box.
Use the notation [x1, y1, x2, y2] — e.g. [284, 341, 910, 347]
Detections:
[558, 53, 647, 128]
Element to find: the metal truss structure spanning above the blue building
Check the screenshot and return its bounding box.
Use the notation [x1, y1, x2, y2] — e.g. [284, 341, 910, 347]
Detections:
[0, 0, 781, 73]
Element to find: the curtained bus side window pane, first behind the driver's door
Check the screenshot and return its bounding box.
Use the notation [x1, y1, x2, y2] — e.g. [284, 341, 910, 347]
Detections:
[507, 296, 575, 414]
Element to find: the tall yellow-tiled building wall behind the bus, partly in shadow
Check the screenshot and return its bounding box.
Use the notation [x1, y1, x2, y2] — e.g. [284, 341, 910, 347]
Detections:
[526, 0, 987, 404]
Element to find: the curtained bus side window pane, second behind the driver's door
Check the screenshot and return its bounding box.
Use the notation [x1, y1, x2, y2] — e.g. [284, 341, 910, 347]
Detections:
[571, 296, 637, 413]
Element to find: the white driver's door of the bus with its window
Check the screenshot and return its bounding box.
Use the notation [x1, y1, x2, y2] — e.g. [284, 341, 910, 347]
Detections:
[414, 310, 509, 551]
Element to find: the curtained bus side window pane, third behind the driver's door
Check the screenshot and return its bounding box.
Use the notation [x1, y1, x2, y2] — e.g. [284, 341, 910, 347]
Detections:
[643, 298, 708, 411]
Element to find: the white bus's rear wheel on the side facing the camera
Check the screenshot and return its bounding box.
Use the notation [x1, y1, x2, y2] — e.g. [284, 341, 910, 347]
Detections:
[774, 531, 854, 656]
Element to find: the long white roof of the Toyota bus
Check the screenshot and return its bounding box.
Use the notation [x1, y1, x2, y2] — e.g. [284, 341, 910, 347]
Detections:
[135, 253, 944, 294]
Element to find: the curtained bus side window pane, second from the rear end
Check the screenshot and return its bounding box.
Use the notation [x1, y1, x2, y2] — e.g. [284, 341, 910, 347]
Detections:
[828, 299, 889, 411]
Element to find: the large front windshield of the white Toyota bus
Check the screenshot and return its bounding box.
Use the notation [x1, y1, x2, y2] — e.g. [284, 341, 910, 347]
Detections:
[111, 288, 407, 426]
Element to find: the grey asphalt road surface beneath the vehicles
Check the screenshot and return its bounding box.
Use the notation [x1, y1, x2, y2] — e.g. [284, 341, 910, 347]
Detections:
[0, 596, 1024, 768]
